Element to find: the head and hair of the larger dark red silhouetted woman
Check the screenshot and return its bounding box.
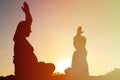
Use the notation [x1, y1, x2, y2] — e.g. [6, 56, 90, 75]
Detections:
[14, 21, 31, 40]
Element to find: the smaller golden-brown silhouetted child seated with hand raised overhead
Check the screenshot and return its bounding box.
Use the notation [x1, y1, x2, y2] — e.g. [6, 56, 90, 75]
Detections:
[65, 26, 89, 80]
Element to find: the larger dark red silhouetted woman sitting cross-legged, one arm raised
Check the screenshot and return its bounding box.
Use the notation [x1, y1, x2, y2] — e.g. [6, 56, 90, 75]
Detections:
[13, 2, 55, 80]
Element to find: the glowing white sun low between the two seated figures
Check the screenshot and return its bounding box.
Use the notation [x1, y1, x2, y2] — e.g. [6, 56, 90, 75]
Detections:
[55, 59, 71, 73]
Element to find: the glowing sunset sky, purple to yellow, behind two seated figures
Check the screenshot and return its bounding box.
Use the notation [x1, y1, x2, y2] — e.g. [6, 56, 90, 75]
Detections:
[0, 0, 120, 75]
